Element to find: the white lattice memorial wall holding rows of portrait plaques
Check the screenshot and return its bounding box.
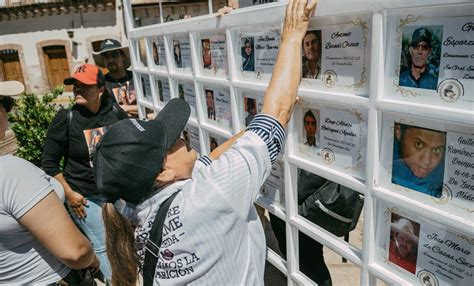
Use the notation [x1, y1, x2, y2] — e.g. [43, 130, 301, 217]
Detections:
[124, 0, 474, 285]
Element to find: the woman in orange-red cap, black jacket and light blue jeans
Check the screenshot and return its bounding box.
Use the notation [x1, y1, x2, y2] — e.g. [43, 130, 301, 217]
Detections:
[42, 64, 128, 280]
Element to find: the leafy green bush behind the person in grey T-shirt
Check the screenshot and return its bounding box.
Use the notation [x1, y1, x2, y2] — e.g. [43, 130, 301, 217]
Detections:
[9, 86, 64, 167]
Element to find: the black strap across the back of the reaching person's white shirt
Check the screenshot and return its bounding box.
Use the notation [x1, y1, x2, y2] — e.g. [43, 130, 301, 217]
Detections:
[143, 190, 179, 286]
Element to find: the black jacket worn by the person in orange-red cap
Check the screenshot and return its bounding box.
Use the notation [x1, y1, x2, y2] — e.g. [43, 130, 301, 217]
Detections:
[42, 93, 127, 196]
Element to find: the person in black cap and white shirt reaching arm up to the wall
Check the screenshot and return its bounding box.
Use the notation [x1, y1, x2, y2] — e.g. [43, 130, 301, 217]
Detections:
[94, 0, 317, 285]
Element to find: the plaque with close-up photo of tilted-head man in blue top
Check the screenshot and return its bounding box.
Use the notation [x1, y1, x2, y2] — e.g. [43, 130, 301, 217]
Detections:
[378, 112, 474, 216]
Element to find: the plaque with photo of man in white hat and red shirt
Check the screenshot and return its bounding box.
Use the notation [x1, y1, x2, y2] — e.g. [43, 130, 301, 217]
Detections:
[375, 206, 474, 286]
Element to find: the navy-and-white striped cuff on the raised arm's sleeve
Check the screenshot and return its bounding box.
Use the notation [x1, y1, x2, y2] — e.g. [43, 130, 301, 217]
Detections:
[247, 114, 285, 164]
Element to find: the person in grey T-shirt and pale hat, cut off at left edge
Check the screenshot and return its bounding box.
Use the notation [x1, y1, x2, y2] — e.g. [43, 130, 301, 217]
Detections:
[0, 81, 99, 285]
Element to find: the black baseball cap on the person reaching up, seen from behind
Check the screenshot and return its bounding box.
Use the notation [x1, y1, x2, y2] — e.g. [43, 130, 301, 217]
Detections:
[94, 98, 191, 203]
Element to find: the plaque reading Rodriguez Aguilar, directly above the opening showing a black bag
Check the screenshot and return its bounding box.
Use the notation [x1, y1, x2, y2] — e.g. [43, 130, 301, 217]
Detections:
[294, 105, 367, 179]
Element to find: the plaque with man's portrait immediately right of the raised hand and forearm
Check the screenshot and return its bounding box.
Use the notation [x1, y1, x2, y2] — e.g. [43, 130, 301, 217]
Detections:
[300, 14, 371, 96]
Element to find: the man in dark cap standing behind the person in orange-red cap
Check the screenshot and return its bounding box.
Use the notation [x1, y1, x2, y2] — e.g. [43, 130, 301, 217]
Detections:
[93, 39, 138, 117]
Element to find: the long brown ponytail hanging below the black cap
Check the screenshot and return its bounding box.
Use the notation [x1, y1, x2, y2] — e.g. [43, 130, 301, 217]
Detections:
[102, 203, 139, 286]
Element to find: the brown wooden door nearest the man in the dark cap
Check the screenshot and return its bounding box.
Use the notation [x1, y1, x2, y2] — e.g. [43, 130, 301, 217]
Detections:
[43, 46, 72, 91]
